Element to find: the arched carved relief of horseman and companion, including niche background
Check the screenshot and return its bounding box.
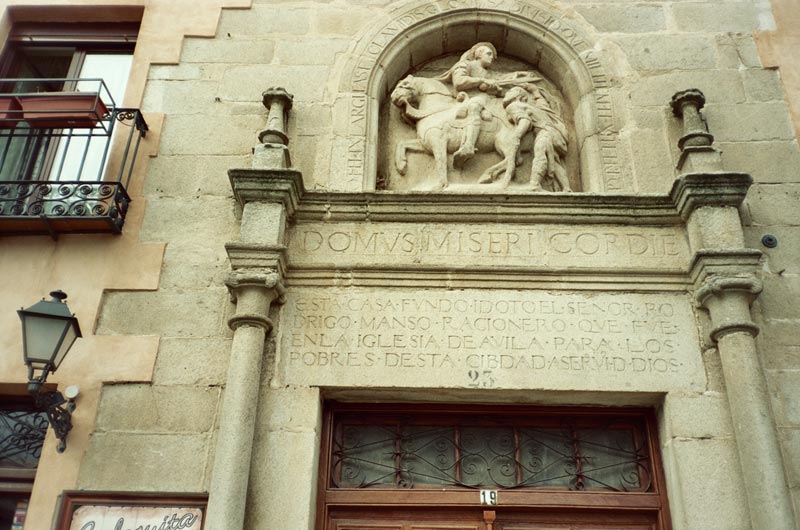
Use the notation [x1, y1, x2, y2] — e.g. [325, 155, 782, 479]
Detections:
[378, 42, 579, 193]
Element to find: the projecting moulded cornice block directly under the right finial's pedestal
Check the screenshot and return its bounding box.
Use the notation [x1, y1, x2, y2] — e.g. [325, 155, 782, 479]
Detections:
[669, 172, 753, 220]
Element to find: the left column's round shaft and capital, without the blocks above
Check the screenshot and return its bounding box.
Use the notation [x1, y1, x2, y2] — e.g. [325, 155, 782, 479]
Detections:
[205, 270, 285, 530]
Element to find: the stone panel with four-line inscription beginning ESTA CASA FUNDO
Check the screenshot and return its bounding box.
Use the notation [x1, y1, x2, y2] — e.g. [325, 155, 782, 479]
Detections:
[276, 288, 705, 392]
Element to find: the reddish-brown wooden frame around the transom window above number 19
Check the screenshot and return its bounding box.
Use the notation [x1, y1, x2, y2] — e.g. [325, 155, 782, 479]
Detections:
[317, 401, 671, 530]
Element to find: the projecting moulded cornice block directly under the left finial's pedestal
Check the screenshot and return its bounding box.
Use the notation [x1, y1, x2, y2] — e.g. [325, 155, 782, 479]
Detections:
[233, 169, 305, 213]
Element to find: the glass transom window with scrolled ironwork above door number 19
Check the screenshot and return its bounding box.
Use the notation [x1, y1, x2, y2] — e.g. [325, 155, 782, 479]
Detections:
[330, 411, 652, 492]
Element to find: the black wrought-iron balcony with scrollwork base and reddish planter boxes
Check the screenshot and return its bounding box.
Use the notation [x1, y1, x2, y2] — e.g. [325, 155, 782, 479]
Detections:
[0, 79, 147, 238]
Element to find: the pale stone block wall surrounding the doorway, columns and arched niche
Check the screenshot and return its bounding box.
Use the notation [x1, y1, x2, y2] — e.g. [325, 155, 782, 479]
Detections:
[65, 0, 800, 530]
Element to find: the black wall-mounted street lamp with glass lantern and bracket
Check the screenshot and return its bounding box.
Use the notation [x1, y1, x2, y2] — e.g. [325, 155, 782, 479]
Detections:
[17, 291, 81, 453]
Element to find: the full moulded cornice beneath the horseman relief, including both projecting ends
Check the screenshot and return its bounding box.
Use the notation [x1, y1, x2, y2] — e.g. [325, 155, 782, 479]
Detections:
[219, 169, 752, 225]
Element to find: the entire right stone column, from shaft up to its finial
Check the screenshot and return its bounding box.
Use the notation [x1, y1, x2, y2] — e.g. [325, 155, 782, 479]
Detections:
[671, 89, 795, 530]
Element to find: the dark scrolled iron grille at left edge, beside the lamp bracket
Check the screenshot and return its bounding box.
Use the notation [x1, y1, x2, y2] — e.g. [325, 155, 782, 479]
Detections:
[0, 410, 47, 469]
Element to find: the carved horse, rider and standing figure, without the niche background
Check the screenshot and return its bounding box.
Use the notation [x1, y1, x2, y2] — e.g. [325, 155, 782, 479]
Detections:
[391, 42, 572, 191]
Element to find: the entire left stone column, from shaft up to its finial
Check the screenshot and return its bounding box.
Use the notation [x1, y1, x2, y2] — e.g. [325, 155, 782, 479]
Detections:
[206, 88, 303, 530]
